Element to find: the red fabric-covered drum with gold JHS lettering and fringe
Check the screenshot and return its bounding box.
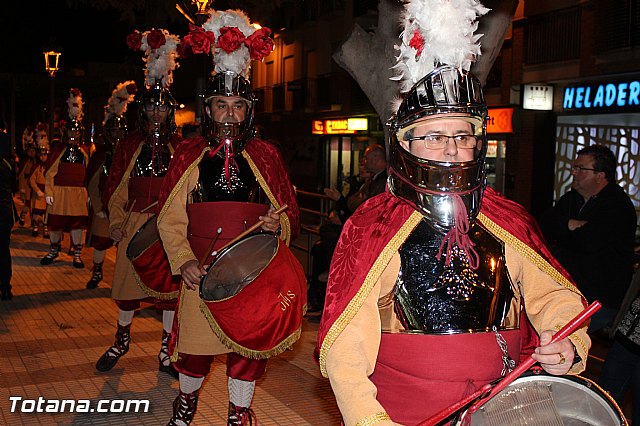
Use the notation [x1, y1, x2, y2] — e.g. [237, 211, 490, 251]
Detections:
[200, 234, 307, 359]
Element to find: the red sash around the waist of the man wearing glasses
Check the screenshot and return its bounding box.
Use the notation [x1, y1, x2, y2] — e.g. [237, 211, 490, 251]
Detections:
[371, 330, 520, 425]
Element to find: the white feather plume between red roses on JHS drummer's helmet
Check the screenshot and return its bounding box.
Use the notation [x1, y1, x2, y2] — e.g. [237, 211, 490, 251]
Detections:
[202, 10, 256, 79]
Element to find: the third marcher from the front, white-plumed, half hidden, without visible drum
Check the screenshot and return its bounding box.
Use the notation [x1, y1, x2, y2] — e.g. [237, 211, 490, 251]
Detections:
[85, 80, 136, 289]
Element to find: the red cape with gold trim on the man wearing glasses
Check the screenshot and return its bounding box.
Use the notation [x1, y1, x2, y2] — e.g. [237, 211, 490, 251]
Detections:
[316, 188, 586, 364]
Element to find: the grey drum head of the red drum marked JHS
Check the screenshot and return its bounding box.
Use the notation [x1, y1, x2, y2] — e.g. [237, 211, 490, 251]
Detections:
[200, 234, 278, 301]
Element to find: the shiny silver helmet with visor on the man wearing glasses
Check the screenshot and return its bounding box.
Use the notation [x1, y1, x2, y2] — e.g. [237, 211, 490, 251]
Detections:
[388, 66, 487, 229]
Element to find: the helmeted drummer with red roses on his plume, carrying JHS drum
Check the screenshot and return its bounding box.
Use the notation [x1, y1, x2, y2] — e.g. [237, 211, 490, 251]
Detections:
[158, 11, 306, 425]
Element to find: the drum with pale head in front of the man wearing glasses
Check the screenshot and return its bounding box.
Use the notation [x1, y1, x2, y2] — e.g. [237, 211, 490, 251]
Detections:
[463, 375, 628, 426]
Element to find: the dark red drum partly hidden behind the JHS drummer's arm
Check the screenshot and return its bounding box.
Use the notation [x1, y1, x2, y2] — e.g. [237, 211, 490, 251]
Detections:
[127, 215, 180, 299]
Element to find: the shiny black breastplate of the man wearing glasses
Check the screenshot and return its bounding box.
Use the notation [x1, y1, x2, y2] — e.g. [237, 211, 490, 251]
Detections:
[394, 221, 519, 334]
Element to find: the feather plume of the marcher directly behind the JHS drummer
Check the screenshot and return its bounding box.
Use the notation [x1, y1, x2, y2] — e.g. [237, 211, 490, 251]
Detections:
[140, 29, 180, 88]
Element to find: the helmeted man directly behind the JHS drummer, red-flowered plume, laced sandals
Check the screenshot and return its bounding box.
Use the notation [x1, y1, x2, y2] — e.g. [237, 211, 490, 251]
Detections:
[96, 29, 180, 376]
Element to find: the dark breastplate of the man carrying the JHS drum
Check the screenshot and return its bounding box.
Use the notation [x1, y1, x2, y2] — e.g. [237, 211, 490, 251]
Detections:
[190, 154, 268, 204]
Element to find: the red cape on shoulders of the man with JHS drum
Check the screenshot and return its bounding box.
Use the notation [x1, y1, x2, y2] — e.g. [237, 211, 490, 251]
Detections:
[156, 137, 300, 239]
